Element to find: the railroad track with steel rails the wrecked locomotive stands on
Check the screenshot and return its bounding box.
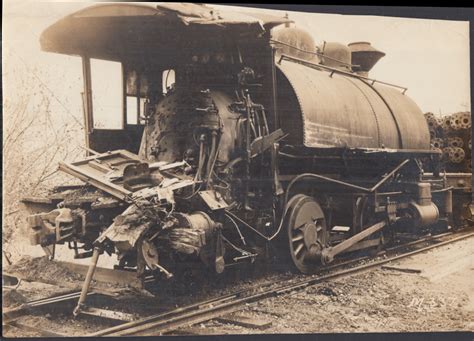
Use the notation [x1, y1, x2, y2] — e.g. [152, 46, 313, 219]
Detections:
[4, 227, 474, 337]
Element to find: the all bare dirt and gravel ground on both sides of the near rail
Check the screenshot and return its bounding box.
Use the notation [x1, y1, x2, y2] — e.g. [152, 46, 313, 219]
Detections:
[3, 234, 474, 336]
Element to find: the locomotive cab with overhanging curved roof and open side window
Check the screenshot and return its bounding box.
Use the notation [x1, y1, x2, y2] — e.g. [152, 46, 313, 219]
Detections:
[41, 4, 290, 153]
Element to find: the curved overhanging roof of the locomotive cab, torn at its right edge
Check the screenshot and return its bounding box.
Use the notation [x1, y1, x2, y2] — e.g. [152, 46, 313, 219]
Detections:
[40, 3, 291, 60]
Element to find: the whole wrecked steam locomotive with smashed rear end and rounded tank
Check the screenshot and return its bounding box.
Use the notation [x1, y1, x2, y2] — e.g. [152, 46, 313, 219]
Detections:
[20, 4, 469, 312]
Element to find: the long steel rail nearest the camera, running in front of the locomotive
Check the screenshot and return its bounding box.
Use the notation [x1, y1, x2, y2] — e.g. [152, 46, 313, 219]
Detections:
[88, 228, 474, 336]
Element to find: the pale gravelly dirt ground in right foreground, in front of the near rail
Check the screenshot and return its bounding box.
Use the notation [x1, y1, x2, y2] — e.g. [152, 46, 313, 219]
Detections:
[183, 238, 474, 334]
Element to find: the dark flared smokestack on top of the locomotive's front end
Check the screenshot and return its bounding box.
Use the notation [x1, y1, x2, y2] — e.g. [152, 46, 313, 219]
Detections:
[347, 41, 385, 77]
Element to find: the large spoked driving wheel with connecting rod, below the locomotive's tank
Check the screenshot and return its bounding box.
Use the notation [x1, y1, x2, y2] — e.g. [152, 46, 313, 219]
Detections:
[287, 195, 326, 273]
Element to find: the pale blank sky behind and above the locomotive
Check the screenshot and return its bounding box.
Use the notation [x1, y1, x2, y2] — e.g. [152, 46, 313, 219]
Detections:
[2, 0, 470, 119]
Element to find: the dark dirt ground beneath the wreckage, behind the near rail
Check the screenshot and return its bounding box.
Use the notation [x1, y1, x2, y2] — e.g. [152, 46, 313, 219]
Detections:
[2, 257, 301, 337]
